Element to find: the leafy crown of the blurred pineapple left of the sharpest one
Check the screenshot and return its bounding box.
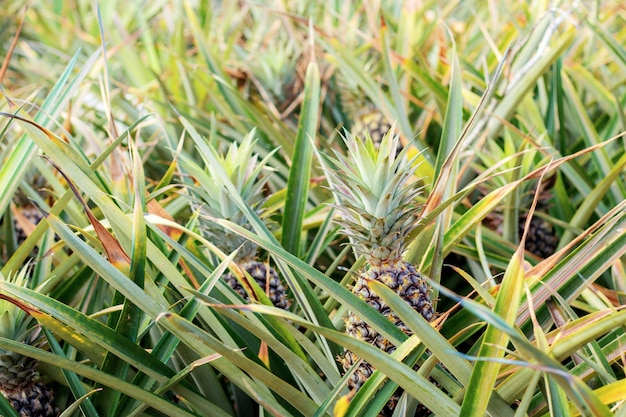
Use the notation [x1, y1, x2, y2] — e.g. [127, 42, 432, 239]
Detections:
[183, 130, 273, 262]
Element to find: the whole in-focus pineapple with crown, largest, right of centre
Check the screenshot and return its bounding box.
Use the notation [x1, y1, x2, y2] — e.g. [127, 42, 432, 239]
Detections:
[326, 127, 434, 408]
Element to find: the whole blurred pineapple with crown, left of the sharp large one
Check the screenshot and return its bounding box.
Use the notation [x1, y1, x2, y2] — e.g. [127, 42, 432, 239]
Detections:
[186, 132, 289, 309]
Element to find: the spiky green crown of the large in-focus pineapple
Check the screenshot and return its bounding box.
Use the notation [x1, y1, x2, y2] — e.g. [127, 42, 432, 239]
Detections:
[325, 127, 422, 266]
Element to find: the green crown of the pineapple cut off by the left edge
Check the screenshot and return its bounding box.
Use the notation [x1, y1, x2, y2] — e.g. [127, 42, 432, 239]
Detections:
[0, 268, 33, 342]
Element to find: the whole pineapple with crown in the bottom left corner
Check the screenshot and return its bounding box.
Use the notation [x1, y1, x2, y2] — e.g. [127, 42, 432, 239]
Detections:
[0, 268, 59, 417]
